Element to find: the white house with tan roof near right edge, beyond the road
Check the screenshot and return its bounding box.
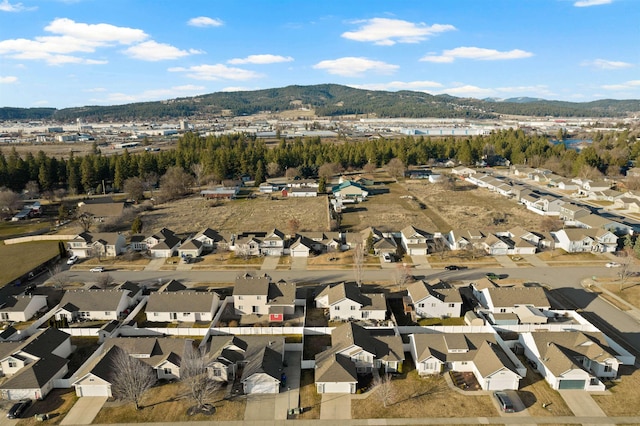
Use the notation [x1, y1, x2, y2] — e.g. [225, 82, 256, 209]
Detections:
[551, 228, 618, 253]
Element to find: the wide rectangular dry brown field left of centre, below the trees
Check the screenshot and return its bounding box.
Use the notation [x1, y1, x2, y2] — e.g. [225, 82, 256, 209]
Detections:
[142, 195, 329, 234]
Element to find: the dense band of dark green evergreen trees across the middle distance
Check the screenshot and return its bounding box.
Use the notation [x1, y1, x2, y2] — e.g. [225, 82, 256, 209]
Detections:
[0, 129, 640, 198]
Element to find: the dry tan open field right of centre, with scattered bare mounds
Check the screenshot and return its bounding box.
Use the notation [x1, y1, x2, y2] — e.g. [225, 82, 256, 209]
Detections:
[402, 179, 542, 232]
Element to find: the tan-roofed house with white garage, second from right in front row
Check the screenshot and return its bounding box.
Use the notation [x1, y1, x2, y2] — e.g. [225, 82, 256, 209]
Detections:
[409, 333, 526, 391]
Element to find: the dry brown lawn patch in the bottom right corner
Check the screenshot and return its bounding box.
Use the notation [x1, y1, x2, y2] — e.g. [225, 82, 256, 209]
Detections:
[592, 366, 640, 416]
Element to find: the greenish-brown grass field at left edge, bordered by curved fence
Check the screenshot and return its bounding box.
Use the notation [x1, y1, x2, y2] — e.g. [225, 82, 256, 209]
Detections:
[0, 241, 59, 284]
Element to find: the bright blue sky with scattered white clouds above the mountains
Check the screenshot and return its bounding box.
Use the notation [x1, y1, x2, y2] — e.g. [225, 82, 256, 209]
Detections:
[0, 0, 640, 108]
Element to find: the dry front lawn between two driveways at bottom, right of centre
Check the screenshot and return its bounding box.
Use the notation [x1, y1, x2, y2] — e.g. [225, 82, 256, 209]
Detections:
[351, 362, 497, 419]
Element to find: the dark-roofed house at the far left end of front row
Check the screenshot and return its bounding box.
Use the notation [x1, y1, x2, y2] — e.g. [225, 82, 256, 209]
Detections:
[0, 328, 72, 401]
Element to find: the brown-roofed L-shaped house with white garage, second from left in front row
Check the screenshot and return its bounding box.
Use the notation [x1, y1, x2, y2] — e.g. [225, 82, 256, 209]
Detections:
[72, 337, 194, 397]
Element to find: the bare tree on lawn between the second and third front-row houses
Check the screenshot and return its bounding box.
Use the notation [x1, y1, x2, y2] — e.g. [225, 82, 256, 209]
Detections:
[180, 346, 222, 409]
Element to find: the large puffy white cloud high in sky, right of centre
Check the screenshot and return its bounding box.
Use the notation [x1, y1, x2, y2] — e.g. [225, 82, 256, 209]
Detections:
[342, 18, 456, 46]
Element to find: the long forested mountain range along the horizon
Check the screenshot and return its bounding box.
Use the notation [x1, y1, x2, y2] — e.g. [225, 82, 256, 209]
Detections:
[0, 84, 640, 122]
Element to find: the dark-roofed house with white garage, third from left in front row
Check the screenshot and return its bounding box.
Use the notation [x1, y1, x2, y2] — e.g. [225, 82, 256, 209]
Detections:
[205, 336, 284, 394]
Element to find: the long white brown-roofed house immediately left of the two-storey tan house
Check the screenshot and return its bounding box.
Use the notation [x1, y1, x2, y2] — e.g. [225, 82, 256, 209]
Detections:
[145, 291, 220, 323]
